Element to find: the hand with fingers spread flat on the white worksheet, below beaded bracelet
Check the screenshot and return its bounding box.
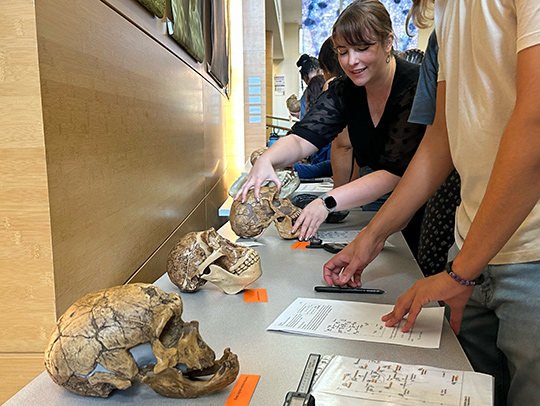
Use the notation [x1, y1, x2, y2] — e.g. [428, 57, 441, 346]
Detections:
[382, 272, 474, 334]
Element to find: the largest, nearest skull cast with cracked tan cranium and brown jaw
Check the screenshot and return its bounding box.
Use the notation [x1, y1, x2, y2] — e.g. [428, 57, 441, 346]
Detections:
[45, 283, 239, 398]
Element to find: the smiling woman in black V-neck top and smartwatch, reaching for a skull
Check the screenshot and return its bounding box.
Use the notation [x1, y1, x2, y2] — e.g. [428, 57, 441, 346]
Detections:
[236, 0, 425, 249]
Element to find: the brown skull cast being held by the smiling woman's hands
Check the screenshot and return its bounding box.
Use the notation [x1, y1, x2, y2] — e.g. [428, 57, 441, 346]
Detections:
[229, 186, 302, 239]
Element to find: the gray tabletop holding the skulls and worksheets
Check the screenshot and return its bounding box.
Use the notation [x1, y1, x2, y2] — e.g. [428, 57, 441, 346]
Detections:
[5, 211, 472, 406]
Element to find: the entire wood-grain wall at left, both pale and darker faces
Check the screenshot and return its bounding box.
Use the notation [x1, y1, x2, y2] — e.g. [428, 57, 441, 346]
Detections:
[0, 0, 238, 403]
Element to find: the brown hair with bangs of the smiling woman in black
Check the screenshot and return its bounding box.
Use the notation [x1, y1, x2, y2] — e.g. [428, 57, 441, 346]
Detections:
[332, 0, 393, 50]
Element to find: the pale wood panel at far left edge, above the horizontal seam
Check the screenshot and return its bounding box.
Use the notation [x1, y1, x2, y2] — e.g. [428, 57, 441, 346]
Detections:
[0, 0, 55, 352]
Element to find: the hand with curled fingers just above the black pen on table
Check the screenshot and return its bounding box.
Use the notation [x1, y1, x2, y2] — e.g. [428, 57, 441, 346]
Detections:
[323, 227, 385, 287]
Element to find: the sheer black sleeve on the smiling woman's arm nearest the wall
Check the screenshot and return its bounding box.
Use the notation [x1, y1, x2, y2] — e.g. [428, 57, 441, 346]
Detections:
[289, 79, 347, 149]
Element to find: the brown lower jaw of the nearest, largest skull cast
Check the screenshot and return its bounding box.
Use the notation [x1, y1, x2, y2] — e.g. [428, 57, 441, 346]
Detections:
[142, 348, 240, 398]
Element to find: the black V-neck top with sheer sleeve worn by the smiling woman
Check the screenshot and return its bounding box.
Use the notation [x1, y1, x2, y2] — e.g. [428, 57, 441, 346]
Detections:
[290, 58, 425, 176]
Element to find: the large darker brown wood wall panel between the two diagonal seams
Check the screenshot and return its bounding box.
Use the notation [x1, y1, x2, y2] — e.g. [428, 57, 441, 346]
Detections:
[36, 0, 211, 314]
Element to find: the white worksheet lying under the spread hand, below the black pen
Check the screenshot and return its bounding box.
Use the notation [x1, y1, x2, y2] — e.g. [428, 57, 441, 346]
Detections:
[267, 298, 444, 348]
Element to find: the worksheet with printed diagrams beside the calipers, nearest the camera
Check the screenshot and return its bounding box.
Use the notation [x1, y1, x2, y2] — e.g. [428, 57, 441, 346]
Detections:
[313, 356, 493, 406]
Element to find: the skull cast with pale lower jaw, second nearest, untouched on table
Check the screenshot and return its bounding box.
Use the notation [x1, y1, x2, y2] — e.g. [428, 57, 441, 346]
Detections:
[167, 228, 262, 295]
